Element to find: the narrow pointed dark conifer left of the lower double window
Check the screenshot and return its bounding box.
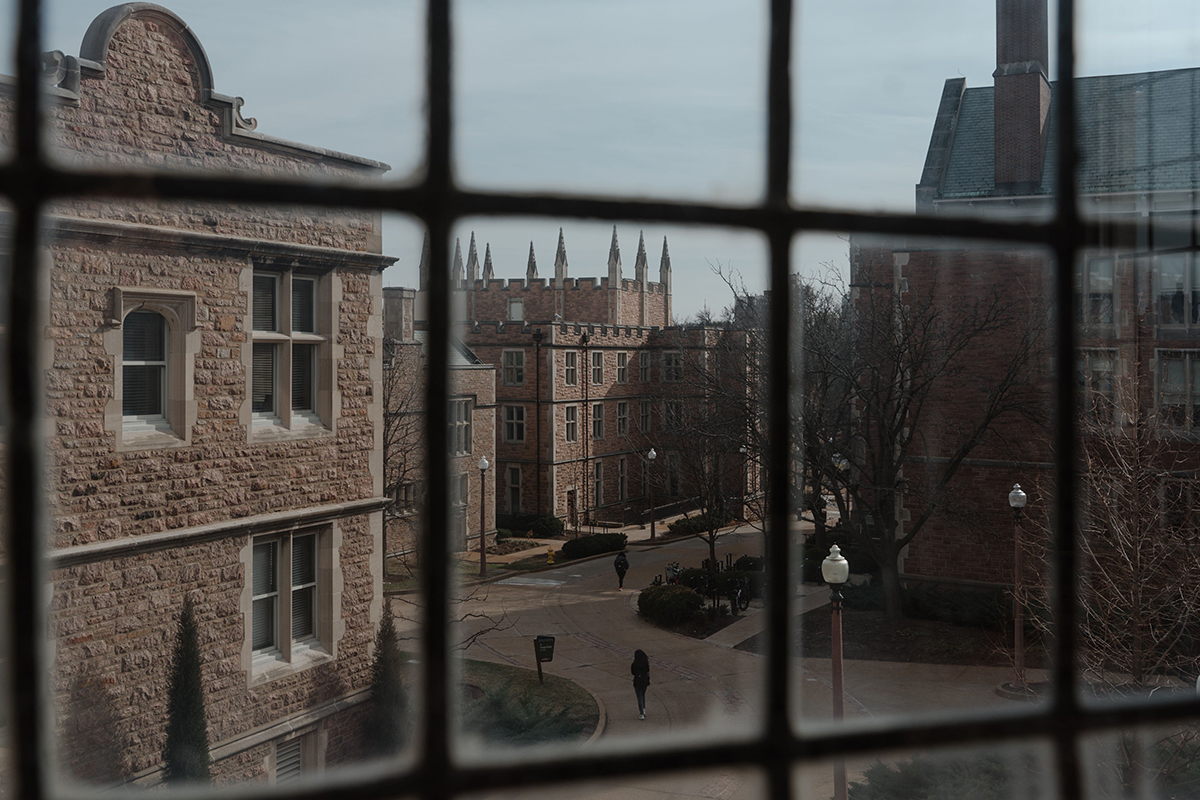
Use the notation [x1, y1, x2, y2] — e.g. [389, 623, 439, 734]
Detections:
[162, 597, 212, 783]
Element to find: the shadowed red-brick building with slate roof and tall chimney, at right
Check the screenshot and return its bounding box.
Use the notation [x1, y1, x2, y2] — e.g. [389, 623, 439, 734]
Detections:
[851, 0, 1200, 582]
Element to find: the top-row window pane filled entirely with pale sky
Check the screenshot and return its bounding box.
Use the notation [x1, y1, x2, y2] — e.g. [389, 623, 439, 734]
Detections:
[454, 0, 767, 203]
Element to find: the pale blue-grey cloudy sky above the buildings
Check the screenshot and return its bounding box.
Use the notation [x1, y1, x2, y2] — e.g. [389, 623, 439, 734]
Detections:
[23, 0, 1200, 317]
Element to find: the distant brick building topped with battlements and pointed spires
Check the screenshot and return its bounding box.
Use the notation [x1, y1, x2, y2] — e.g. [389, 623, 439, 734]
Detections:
[408, 228, 746, 530]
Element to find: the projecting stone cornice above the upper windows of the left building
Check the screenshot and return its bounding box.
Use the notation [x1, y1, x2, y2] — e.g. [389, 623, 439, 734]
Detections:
[47, 215, 400, 270]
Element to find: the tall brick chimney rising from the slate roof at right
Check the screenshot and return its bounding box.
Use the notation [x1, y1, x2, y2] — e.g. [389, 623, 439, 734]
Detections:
[992, 0, 1050, 194]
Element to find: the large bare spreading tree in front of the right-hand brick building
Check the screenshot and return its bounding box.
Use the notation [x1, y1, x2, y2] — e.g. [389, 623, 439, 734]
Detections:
[803, 262, 1046, 619]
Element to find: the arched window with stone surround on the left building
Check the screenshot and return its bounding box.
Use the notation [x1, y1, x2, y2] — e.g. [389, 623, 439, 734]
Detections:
[121, 311, 167, 431]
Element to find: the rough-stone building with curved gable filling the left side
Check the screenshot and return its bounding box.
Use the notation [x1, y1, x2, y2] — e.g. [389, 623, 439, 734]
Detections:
[32, 2, 395, 784]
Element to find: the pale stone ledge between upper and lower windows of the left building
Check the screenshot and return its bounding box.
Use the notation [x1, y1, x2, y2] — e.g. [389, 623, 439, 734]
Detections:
[47, 498, 391, 570]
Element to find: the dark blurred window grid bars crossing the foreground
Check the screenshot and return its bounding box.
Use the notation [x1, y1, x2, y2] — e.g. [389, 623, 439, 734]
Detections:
[0, 0, 1171, 800]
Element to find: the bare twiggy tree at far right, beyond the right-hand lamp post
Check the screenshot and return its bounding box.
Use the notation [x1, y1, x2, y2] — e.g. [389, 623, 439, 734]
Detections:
[1022, 356, 1200, 695]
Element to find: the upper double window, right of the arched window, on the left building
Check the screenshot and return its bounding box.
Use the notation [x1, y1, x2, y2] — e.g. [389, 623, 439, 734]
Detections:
[251, 272, 324, 427]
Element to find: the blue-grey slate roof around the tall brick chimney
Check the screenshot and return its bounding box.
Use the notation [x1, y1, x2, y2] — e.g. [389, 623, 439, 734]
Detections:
[937, 68, 1200, 199]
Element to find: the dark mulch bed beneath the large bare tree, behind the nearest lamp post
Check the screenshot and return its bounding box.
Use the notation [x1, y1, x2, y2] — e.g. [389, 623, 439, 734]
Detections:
[737, 606, 1049, 668]
